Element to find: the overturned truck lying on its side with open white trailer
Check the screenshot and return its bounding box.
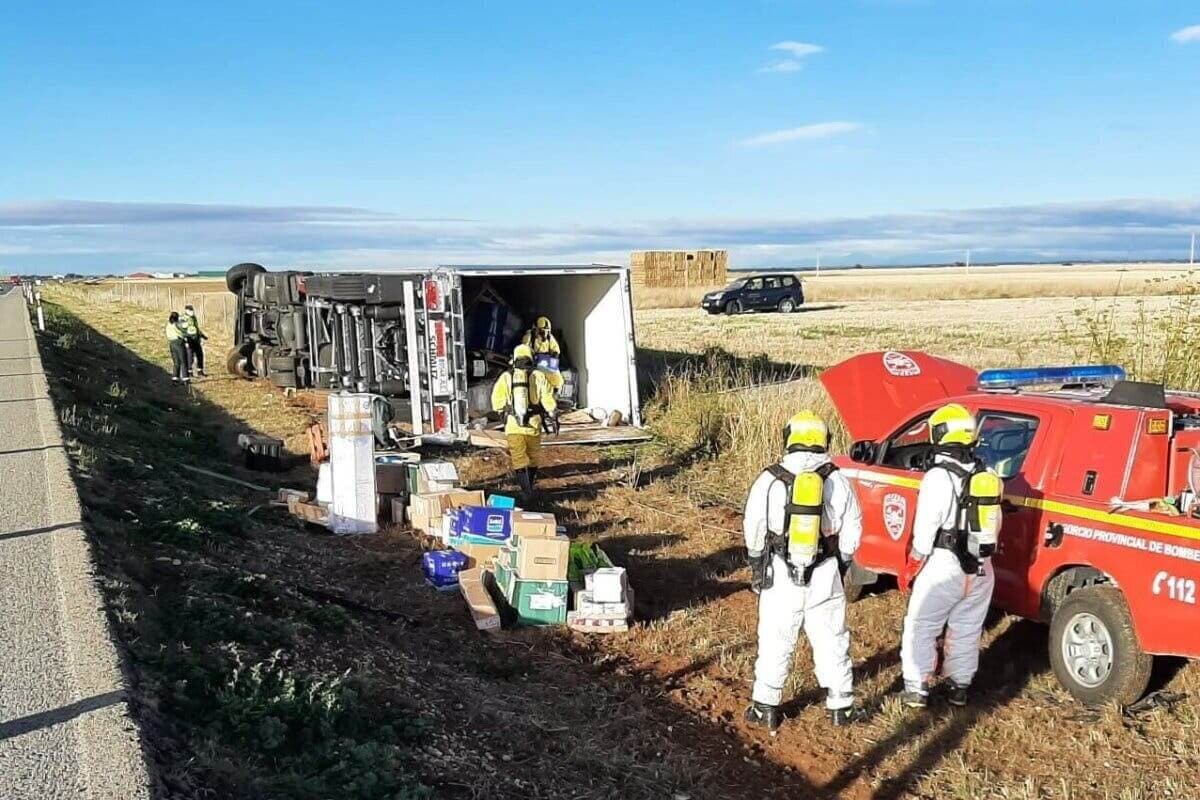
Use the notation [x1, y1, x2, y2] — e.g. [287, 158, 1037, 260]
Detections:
[226, 264, 642, 443]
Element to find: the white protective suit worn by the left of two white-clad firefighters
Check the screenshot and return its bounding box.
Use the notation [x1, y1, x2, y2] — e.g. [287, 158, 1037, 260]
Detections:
[742, 452, 863, 709]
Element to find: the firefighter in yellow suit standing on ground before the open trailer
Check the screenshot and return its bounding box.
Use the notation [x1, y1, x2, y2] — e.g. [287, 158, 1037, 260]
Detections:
[492, 344, 558, 498]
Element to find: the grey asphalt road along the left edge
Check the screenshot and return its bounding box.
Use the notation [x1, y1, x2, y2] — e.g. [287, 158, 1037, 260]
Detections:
[0, 291, 150, 800]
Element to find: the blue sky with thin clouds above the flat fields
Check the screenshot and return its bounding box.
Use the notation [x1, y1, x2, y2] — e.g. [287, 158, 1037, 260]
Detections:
[0, 0, 1200, 271]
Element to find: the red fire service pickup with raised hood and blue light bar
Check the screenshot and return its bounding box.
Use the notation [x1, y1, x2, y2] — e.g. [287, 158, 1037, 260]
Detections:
[821, 351, 1200, 705]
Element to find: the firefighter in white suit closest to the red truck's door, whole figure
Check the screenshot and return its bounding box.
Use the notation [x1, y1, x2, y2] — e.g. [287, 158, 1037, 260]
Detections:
[900, 403, 1001, 708]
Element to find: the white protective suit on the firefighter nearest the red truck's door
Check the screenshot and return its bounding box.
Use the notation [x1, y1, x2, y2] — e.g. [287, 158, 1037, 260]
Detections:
[900, 453, 996, 693]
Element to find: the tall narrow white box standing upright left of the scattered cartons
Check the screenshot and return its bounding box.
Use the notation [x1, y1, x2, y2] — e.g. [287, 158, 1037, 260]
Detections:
[328, 393, 379, 534]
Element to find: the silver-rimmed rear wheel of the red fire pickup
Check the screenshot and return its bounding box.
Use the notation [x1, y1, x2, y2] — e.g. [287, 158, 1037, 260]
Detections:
[1050, 587, 1154, 708]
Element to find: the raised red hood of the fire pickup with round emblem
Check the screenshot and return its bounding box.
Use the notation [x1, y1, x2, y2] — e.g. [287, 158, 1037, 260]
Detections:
[821, 350, 979, 441]
